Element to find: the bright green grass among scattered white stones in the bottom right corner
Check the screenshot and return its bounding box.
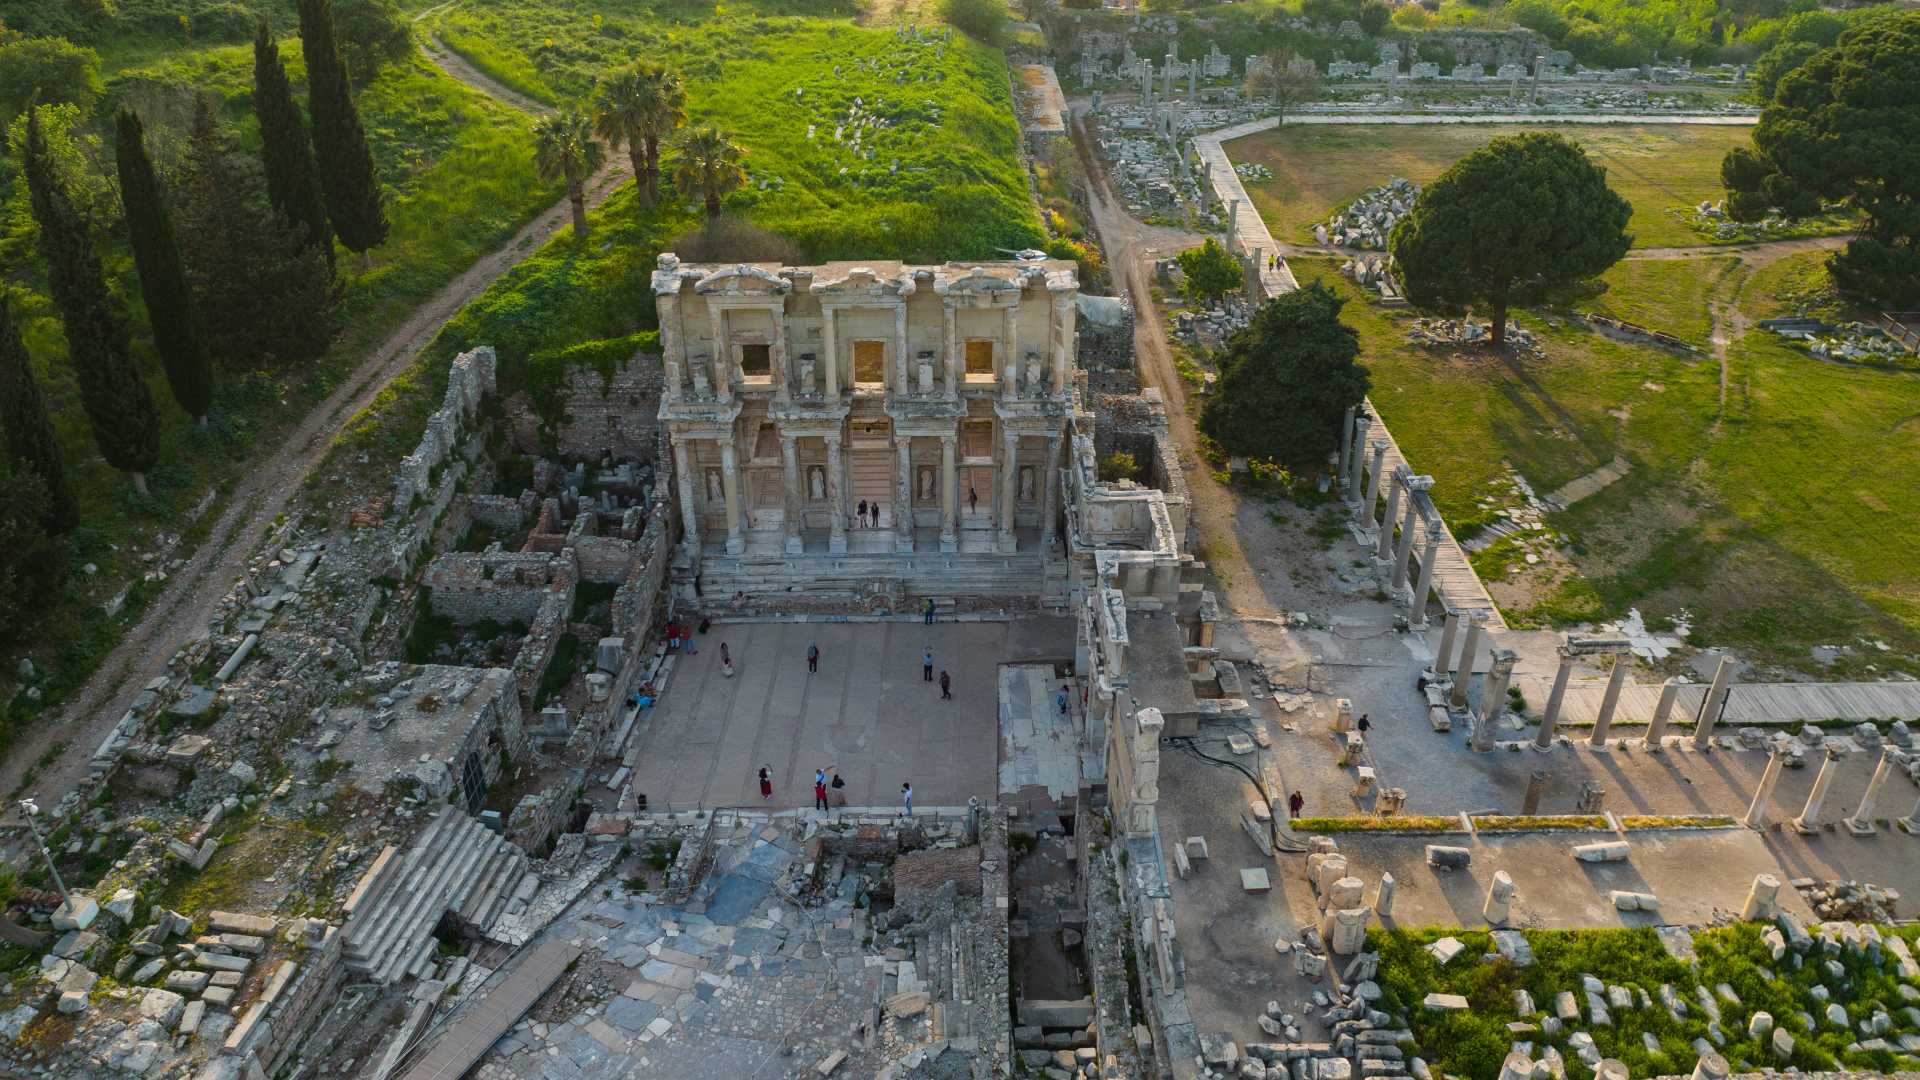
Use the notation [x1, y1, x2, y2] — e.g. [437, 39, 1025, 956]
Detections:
[1367, 922, 1912, 1080]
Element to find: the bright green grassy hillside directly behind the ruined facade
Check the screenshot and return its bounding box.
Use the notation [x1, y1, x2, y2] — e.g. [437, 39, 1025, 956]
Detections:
[432, 0, 1043, 261]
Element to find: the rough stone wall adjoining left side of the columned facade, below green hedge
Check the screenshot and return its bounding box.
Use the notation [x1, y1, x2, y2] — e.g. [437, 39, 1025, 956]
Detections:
[507, 354, 664, 461]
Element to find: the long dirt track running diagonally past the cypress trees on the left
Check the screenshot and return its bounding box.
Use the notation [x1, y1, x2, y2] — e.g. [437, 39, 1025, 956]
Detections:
[0, 33, 632, 813]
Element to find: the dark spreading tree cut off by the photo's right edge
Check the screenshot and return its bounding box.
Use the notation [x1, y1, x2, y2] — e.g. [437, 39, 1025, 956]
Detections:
[1720, 12, 1920, 307]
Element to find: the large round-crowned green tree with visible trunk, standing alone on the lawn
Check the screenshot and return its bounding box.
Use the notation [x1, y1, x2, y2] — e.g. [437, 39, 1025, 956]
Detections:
[1388, 131, 1634, 346]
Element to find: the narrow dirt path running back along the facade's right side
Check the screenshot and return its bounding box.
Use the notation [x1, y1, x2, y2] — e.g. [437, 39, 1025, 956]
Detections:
[1073, 104, 1279, 619]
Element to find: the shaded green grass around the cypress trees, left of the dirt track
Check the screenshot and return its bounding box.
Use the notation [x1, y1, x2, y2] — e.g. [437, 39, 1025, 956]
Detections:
[0, 40, 559, 751]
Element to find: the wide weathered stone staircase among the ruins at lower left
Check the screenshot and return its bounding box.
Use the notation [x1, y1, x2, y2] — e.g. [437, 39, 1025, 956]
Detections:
[344, 807, 530, 984]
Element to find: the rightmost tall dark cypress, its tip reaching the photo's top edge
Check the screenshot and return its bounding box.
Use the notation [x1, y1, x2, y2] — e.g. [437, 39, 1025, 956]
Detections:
[300, 0, 388, 256]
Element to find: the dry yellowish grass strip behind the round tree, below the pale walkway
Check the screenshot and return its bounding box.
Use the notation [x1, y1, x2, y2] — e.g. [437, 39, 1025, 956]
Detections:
[1229, 125, 1822, 248]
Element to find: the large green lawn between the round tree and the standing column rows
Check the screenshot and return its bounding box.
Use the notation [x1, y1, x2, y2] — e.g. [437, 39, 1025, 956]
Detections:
[1292, 254, 1920, 667]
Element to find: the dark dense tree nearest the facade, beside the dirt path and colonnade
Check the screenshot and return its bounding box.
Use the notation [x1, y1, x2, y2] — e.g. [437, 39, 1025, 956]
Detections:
[1200, 281, 1369, 469]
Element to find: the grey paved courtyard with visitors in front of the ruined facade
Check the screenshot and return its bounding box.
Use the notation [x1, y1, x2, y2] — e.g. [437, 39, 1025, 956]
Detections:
[634, 617, 1073, 811]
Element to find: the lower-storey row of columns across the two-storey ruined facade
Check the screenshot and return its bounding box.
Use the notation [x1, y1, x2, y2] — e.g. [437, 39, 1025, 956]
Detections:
[672, 420, 1066, 555]
